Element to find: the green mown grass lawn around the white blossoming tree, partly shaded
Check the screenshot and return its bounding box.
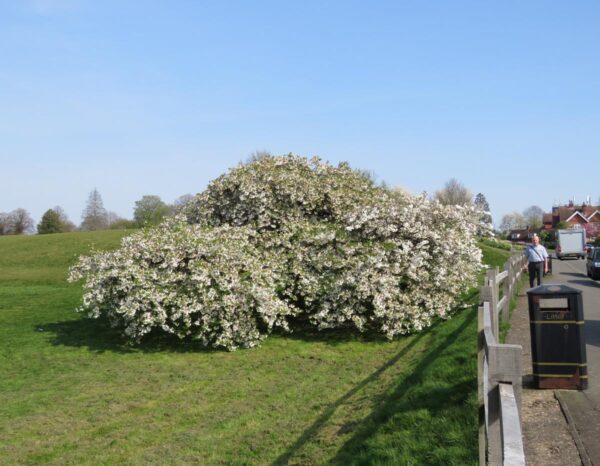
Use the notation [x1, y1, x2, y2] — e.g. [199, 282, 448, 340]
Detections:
[0, 231, 507, 465]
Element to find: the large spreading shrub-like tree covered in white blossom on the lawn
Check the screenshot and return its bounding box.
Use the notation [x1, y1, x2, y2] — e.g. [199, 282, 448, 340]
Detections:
[70, 155, 481, 350]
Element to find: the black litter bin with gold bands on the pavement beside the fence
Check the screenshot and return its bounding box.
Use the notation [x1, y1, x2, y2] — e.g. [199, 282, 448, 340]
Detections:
[527, 284, 588, 390]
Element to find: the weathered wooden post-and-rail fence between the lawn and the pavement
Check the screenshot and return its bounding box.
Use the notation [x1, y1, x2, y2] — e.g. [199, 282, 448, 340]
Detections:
[477, 254, 526, 466]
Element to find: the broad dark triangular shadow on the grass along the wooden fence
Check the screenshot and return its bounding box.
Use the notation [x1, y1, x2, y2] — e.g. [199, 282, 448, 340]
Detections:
[331, 312, 477, 465]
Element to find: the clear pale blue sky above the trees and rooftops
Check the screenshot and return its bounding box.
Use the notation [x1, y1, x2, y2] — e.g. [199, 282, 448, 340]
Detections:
[0, 0, 600, 228]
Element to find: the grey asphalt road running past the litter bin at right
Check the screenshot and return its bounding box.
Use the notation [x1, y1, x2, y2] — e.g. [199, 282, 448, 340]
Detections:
[545, 259, 600, 466]
